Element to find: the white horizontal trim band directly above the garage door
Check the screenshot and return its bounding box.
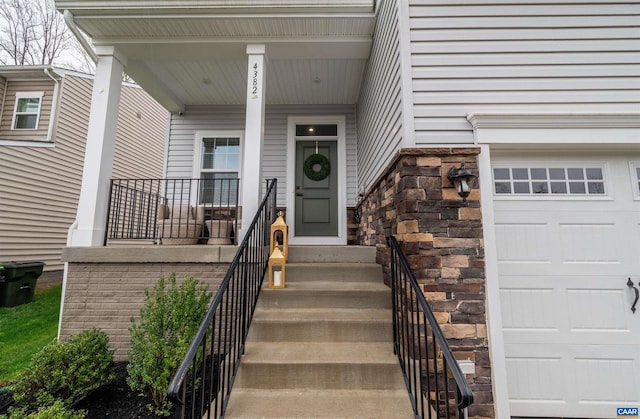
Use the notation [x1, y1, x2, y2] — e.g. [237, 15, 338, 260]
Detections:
[467, 112, 640, 145]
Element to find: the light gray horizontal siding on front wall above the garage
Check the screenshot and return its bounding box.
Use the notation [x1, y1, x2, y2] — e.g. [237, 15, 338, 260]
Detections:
[409, 0, 640, 144]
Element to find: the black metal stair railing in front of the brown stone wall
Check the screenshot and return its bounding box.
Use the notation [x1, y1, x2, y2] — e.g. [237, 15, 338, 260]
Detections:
[388, 237, 473, 419]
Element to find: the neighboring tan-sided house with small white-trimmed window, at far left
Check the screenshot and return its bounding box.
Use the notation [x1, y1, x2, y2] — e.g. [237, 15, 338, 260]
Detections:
[0, 66, 168, 270]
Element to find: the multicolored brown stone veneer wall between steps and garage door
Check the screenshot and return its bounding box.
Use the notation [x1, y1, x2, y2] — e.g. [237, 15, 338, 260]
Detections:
[355, 148, 494, 418]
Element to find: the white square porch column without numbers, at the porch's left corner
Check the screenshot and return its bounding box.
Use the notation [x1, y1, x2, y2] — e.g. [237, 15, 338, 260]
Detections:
[67, 47, 126, 246]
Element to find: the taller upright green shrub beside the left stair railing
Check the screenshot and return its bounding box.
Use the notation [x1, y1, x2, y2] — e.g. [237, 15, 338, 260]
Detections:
[127, 274, 212, 416]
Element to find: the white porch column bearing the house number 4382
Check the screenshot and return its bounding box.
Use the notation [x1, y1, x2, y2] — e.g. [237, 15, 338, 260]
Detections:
[239, 44, 265, 240]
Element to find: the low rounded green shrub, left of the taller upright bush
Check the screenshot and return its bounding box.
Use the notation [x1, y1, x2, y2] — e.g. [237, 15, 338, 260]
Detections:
[12, 329, 113, 412]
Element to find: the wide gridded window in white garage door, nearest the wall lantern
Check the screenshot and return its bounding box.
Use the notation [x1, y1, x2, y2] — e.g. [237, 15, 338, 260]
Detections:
[493, 164, 607, 196]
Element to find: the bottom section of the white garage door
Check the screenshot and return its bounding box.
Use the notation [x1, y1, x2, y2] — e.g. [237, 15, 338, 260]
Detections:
[505, 343, 640, 418]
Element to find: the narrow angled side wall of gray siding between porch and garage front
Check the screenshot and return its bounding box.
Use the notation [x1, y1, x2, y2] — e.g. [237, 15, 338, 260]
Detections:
[357, 0, 404, 192]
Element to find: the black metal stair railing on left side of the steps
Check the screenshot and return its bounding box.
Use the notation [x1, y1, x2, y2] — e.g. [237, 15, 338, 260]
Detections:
[169, 179, 277, 419]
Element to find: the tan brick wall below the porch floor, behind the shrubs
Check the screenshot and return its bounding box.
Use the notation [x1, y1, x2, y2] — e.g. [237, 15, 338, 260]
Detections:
[60, 262, 229, 361]
